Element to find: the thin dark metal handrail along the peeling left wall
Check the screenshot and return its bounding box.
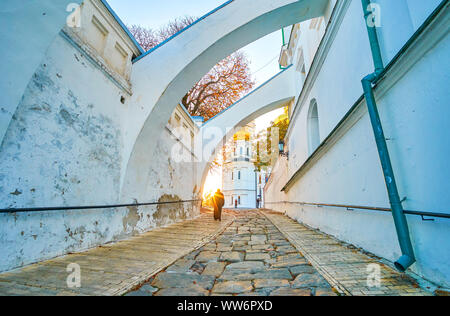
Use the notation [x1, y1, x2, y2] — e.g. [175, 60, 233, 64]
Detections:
[0, 199, 202, 214]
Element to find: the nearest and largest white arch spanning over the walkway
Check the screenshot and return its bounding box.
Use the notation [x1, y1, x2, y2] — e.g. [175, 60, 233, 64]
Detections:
[121, 0, 329, 200]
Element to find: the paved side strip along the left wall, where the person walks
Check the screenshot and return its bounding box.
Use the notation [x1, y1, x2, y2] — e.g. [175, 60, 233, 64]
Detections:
[0, 213, 234, 296]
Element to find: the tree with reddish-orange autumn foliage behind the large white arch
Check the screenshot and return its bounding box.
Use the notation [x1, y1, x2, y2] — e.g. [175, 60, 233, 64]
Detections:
[130, 17, 255, 121]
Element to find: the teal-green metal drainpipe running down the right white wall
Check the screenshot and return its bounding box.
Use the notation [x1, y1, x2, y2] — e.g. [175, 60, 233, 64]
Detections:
[361, 0, 416, 272]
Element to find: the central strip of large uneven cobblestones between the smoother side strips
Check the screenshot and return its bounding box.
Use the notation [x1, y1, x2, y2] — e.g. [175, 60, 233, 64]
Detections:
[127, 210, 336, 296]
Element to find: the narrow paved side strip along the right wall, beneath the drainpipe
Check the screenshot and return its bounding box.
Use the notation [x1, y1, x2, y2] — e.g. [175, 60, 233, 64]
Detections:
[264, 211, 434, 296]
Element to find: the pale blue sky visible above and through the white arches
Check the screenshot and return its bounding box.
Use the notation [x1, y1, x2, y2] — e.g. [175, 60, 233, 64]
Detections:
[108, 0, 283, 130]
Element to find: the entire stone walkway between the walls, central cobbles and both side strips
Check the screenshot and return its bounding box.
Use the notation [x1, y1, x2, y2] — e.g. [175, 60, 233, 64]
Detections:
[0, 210, 431, 296]
